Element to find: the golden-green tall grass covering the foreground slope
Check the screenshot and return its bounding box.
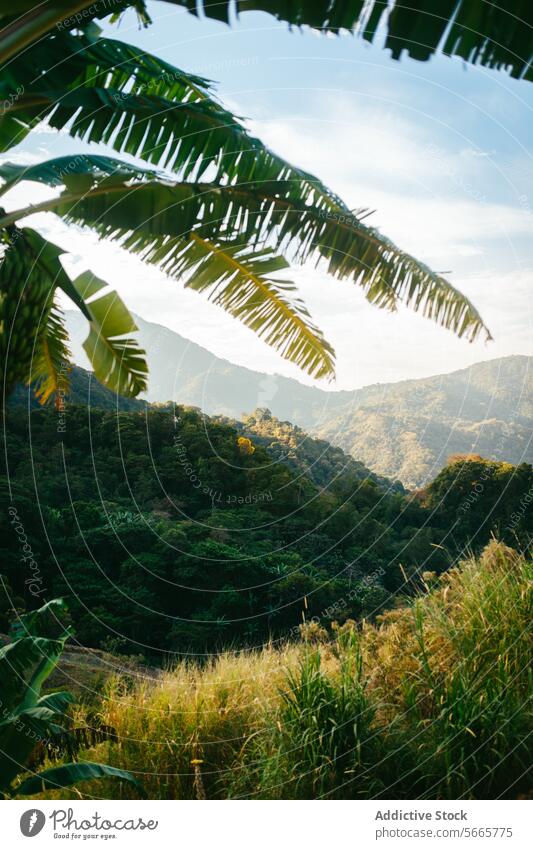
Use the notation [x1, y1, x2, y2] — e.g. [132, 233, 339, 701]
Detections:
[53, 542, 533, 799]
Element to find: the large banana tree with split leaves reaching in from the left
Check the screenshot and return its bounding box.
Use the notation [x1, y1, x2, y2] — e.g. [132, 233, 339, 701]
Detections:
[0, 0, 490, 402]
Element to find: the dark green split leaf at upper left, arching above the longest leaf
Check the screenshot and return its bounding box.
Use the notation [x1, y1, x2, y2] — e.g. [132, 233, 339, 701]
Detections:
[0, 87, 266, 182]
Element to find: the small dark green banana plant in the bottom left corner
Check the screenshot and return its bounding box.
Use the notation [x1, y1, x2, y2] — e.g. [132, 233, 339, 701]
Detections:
[0, 599, 142, 799]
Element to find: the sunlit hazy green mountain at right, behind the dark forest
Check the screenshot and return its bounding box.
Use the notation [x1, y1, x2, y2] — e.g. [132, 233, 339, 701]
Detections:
[311, 356, 533, 487]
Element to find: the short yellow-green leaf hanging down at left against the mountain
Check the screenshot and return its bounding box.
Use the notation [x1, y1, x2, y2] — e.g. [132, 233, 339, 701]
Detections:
[73, 271, 148, 397]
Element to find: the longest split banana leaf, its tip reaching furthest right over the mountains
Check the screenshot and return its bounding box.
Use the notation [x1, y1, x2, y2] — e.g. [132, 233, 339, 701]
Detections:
[38, 169, 491, 340]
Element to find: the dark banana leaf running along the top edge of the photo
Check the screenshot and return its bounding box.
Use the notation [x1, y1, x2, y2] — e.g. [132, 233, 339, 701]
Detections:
[0, 0, 533, 80]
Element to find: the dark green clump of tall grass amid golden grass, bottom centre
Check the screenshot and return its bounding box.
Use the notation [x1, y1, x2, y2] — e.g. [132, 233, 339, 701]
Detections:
[238, 629, 386, 799]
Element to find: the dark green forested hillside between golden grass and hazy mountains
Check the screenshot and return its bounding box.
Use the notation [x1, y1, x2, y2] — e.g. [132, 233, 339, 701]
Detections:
[1, 405, 533, 658]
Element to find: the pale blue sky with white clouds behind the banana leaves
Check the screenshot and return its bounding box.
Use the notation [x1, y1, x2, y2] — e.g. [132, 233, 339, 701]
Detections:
[3, 2, 533, 389]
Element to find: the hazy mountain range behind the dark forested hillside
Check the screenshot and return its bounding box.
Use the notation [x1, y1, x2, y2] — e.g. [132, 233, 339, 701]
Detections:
[64, 313, 533, 487]
